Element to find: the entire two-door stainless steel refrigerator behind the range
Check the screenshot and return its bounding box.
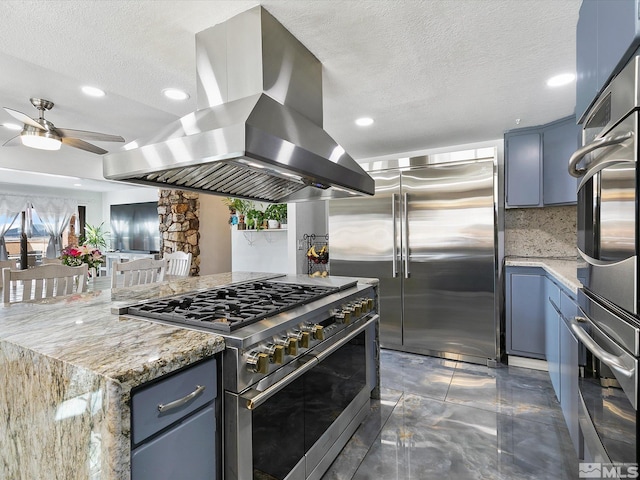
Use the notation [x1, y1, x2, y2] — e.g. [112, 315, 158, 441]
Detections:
[329, 159, 499, 365]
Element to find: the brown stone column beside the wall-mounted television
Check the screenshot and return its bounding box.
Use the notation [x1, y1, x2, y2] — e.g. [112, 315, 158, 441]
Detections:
[158, 190, 200, 276]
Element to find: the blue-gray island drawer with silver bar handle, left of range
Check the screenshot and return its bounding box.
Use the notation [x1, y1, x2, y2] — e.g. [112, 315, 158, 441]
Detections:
[131, 358, 217, 444]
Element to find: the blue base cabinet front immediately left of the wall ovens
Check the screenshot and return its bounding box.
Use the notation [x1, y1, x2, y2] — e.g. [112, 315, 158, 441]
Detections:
[560, 292, 580, 457]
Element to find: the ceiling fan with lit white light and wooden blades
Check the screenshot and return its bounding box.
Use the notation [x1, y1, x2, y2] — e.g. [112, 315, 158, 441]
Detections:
[3, 98, 124, 155]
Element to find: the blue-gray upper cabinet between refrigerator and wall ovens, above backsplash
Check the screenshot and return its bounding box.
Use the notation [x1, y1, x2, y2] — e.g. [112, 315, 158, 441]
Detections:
[504, 116, 580, 207]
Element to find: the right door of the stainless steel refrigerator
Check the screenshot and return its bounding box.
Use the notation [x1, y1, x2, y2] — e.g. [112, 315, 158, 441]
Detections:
[402, 161, 496, 358]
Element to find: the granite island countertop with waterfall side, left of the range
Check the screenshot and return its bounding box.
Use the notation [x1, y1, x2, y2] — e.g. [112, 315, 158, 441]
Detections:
[0, 272, 272, 480]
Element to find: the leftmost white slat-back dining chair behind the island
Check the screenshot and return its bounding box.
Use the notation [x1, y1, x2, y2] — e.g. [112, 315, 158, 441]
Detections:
[2, 263, 88, 304]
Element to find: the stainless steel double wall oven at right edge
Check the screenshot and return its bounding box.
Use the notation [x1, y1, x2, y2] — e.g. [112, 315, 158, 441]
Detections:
[569, 57, 640, 464]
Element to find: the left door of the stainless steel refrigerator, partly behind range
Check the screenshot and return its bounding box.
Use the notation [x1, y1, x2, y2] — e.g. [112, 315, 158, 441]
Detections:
[329, 171, 402, 347]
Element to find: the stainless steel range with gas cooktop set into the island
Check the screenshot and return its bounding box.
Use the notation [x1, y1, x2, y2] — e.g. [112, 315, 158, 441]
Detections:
[121, 275, 379, 480]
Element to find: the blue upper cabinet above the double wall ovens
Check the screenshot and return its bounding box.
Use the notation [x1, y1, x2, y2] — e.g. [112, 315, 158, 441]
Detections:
[576, 0, 640, 123]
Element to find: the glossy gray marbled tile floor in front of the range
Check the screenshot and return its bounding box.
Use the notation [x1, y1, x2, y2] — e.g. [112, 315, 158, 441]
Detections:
[322, 350, 578, 480]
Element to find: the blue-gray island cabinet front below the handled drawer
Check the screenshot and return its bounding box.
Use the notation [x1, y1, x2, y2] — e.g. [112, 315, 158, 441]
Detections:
[131, 407, 217, 480]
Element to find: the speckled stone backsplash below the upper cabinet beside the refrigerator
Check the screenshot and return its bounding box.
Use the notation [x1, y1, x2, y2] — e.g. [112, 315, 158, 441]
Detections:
[504, 205, 577, 257]
